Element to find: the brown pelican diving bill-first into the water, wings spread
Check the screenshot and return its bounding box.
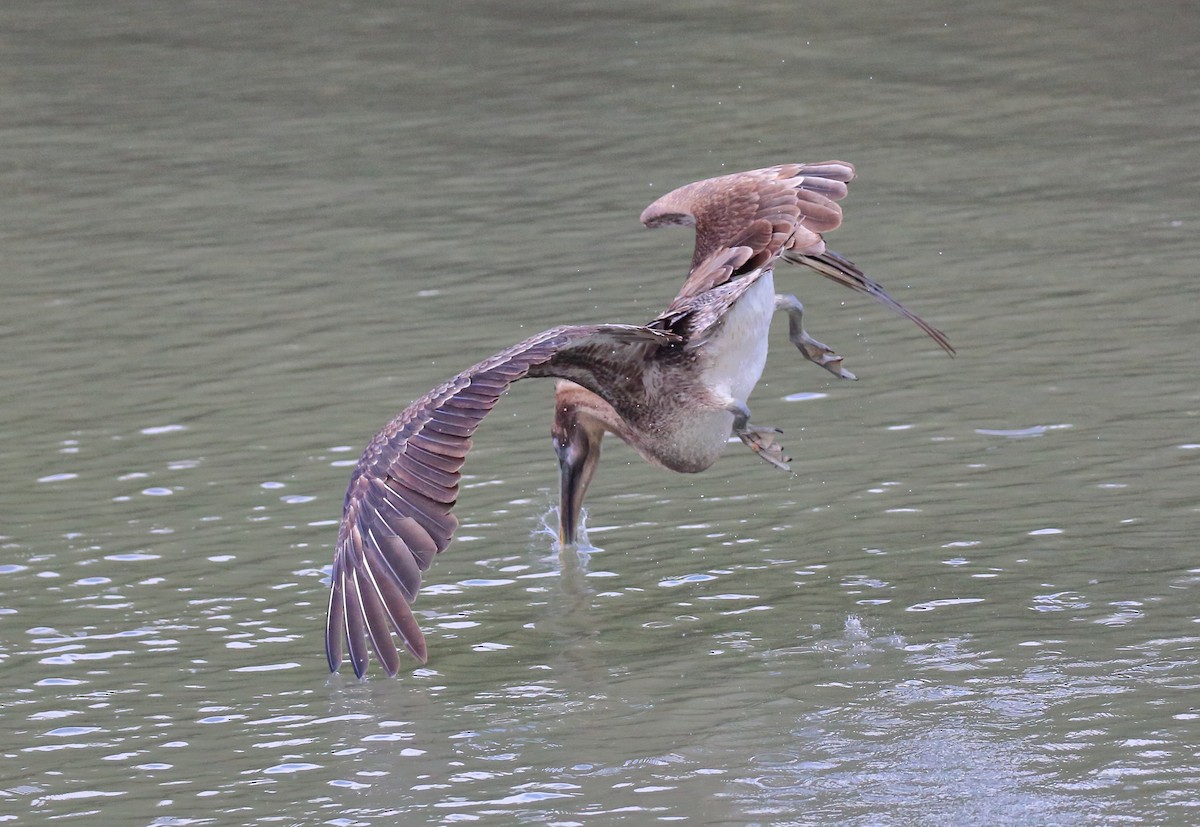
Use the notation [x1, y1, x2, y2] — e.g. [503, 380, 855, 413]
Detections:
[325, 161, 954, 677]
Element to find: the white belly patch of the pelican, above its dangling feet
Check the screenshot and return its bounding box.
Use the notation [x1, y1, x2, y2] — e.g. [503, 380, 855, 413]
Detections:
[704, 272, 775, 404]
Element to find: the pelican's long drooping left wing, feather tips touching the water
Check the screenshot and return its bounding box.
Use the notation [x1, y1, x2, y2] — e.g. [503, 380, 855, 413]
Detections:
[325, 324, 678, 677]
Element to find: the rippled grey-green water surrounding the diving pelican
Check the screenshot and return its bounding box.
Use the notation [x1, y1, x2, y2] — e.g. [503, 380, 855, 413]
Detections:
[0, 0, 1200, 826]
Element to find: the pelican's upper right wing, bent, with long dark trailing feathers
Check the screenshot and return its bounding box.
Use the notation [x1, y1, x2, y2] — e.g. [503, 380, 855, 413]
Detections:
[642, 161, 954, 355]
